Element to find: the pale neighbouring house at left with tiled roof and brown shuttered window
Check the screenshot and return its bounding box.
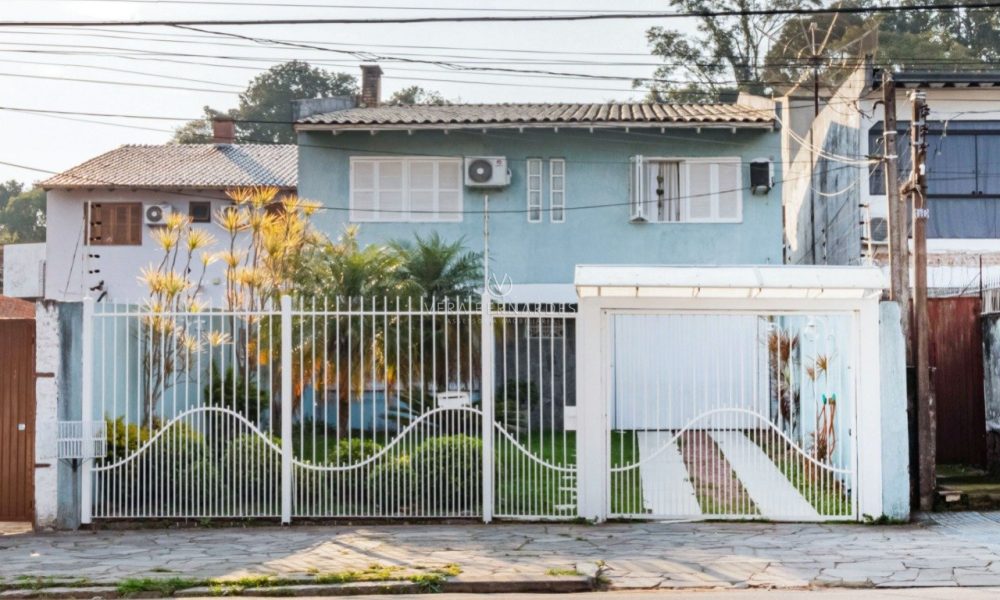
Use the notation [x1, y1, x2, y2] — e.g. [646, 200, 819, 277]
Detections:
[41, 126, 297, 302]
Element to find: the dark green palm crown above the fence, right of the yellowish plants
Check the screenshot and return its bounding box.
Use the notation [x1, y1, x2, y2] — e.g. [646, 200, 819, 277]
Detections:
[391, 232, 483, 298]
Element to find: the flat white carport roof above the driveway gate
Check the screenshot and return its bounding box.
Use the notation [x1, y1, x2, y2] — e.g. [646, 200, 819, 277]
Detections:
[574, 265, 886, 298]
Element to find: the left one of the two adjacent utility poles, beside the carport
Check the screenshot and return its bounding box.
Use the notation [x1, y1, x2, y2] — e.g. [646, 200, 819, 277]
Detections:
[882, 69, 910, 342]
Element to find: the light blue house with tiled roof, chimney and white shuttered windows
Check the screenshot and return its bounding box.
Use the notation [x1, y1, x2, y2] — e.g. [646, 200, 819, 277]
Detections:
[296, 66, 782, 301]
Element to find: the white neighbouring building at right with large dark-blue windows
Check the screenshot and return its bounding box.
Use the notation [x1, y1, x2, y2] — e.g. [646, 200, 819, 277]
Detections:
[782, 65, 1000, 293]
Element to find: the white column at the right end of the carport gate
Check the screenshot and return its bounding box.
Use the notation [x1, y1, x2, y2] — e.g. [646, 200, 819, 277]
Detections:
[854, 299, 884, 519]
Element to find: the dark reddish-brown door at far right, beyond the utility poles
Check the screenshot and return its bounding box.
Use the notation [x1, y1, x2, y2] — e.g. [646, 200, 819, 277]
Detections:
[927, 297, 986, 465]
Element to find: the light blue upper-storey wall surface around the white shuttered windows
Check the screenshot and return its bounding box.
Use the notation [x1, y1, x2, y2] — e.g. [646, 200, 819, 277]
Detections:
[299, 129, 782, 284]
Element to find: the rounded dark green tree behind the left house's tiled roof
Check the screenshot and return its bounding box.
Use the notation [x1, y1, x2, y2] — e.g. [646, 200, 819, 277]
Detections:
[174, 60, 357, 144]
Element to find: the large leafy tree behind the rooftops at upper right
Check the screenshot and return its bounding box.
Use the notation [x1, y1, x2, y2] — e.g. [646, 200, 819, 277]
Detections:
[636, 0, 1000, 102]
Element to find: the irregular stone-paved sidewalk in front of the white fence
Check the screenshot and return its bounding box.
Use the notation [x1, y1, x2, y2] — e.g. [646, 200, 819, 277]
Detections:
[0, 513, 1000, 589]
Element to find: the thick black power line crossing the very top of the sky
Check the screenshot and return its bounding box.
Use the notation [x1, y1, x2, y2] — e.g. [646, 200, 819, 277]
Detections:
[0, 2, 1000, 27]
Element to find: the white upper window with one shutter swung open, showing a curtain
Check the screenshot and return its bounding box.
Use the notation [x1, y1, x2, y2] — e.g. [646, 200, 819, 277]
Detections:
[629, 156, 743, 223]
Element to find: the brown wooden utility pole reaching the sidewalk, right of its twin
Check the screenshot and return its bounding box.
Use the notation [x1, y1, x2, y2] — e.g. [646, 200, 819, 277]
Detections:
[906, 90, 937, 511]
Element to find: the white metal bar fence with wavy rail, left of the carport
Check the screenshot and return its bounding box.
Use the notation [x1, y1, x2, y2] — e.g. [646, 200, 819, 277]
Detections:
[83, 298, 577, 523]
